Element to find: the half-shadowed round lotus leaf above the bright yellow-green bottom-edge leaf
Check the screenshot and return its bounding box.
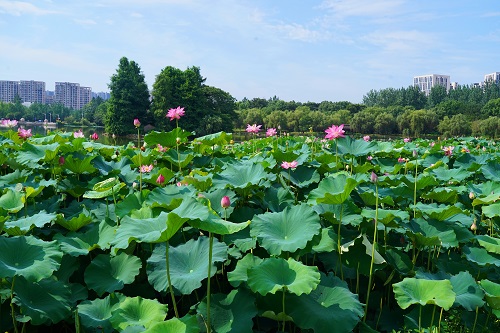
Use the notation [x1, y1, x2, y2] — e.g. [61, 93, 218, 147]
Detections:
[84, 253, 141, 296]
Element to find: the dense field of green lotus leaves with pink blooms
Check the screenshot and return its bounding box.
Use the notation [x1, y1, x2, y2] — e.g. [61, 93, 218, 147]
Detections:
[0, 118, 500, 333]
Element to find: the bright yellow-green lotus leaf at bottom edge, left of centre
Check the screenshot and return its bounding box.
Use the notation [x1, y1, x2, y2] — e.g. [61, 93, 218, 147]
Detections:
[109, 297, 167, 331]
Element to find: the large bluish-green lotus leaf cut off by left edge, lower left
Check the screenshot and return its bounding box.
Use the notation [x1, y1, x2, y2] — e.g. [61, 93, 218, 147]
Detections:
[0, 236, 63, 281]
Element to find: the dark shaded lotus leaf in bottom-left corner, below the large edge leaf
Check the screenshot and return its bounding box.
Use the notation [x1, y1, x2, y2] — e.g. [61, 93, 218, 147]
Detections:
[14, 277, 73, 325]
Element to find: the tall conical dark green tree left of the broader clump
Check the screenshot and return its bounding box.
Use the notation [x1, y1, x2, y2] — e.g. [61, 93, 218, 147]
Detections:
[105, 57, 150, 135]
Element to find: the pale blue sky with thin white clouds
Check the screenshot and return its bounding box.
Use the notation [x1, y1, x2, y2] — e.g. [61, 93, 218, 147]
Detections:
[0, 0, 500, 102]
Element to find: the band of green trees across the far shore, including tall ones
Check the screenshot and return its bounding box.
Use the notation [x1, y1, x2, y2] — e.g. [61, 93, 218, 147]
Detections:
[0, 57, 500, 137]
